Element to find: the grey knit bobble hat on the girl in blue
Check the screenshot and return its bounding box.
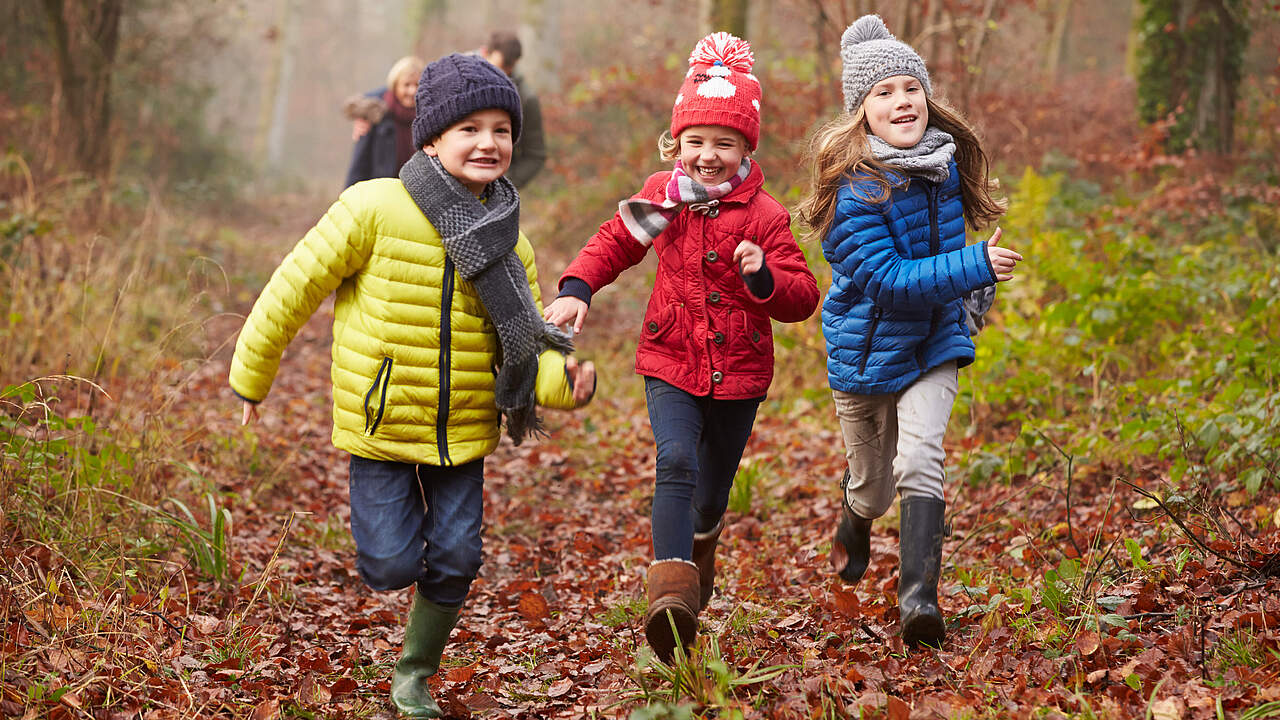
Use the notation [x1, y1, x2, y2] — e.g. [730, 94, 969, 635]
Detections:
[840, 15, 933, 111]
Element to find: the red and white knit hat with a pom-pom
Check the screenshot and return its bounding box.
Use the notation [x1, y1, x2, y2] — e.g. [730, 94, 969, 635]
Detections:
[671, 32, 760, 150]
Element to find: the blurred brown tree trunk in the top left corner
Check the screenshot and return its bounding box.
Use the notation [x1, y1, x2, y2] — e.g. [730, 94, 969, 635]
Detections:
[44, 0, 124, 177]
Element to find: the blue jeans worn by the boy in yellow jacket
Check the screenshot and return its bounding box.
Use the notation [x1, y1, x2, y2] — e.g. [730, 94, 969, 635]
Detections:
[349, 455, 484, 607]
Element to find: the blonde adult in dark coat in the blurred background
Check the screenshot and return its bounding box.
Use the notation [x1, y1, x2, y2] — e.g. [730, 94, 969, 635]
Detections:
[343, 55, 426, 187]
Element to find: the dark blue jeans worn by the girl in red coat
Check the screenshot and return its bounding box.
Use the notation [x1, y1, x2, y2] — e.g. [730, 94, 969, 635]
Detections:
[644, 377, 763, 560]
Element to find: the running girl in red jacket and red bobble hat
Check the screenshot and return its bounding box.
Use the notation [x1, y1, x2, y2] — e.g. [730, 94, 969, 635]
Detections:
[544, 32, 818, 660]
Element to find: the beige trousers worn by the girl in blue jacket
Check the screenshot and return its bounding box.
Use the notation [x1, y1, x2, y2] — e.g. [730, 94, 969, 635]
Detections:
[831, 363, 960, 519]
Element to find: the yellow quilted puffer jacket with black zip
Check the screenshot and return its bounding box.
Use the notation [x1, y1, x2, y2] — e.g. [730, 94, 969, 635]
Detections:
[230, 178, 572, 465]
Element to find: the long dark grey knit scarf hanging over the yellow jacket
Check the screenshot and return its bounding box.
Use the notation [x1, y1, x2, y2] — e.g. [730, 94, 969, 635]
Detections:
[399, 150, 573, 445]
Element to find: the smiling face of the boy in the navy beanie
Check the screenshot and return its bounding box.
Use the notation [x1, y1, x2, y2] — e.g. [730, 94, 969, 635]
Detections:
[422, 108, 512, 196]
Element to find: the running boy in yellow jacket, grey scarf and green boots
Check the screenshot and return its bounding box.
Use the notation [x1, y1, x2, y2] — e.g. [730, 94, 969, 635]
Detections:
[230, 54, 595, 717]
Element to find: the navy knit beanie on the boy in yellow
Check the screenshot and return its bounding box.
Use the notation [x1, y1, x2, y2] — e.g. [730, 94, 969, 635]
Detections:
[413, 53, 521, 150]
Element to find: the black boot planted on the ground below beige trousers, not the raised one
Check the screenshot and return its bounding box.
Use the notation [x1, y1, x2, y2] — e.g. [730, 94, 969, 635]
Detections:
[897, 497, 947, 647]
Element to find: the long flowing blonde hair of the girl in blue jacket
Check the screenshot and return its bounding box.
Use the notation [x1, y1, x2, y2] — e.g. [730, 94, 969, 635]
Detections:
[796, 97, 1007, 240]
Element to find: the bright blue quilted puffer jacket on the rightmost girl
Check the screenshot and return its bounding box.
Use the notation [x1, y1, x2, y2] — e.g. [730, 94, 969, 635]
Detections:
[822, 161, 996, 395]
